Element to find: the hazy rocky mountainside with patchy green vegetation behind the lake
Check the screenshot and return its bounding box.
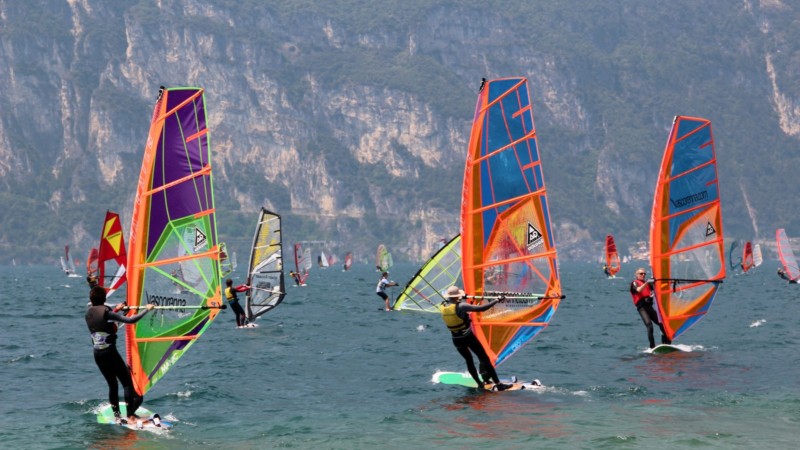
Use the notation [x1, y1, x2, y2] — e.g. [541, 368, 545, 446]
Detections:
[0, 0, 800, 264]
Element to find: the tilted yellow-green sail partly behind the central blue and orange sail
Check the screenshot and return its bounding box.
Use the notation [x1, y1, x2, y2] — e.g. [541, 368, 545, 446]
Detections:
[392, 234, 463, 313]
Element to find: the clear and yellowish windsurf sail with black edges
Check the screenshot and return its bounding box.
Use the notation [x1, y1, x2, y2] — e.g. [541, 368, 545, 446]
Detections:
[245, 208, 286, 321]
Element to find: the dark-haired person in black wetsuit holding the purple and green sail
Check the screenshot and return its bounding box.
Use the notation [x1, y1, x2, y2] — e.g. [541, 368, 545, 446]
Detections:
[85, 286, 153, 422]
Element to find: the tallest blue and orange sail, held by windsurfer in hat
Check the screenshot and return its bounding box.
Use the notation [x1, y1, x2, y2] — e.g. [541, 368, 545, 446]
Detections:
[461, 78, 563, 365]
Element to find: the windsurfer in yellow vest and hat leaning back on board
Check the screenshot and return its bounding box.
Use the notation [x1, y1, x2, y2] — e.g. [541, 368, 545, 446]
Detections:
[441, 286, 510, 391]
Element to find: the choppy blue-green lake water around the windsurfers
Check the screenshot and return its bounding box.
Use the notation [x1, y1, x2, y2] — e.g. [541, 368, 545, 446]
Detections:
[0, 262, 800, 449]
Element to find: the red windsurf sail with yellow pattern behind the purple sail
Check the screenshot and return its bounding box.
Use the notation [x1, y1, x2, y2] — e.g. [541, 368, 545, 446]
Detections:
[97, 211, 128, 297]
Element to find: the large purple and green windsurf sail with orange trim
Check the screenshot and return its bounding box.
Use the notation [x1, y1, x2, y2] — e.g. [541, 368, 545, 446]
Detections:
[125, 87, 225, 395]
